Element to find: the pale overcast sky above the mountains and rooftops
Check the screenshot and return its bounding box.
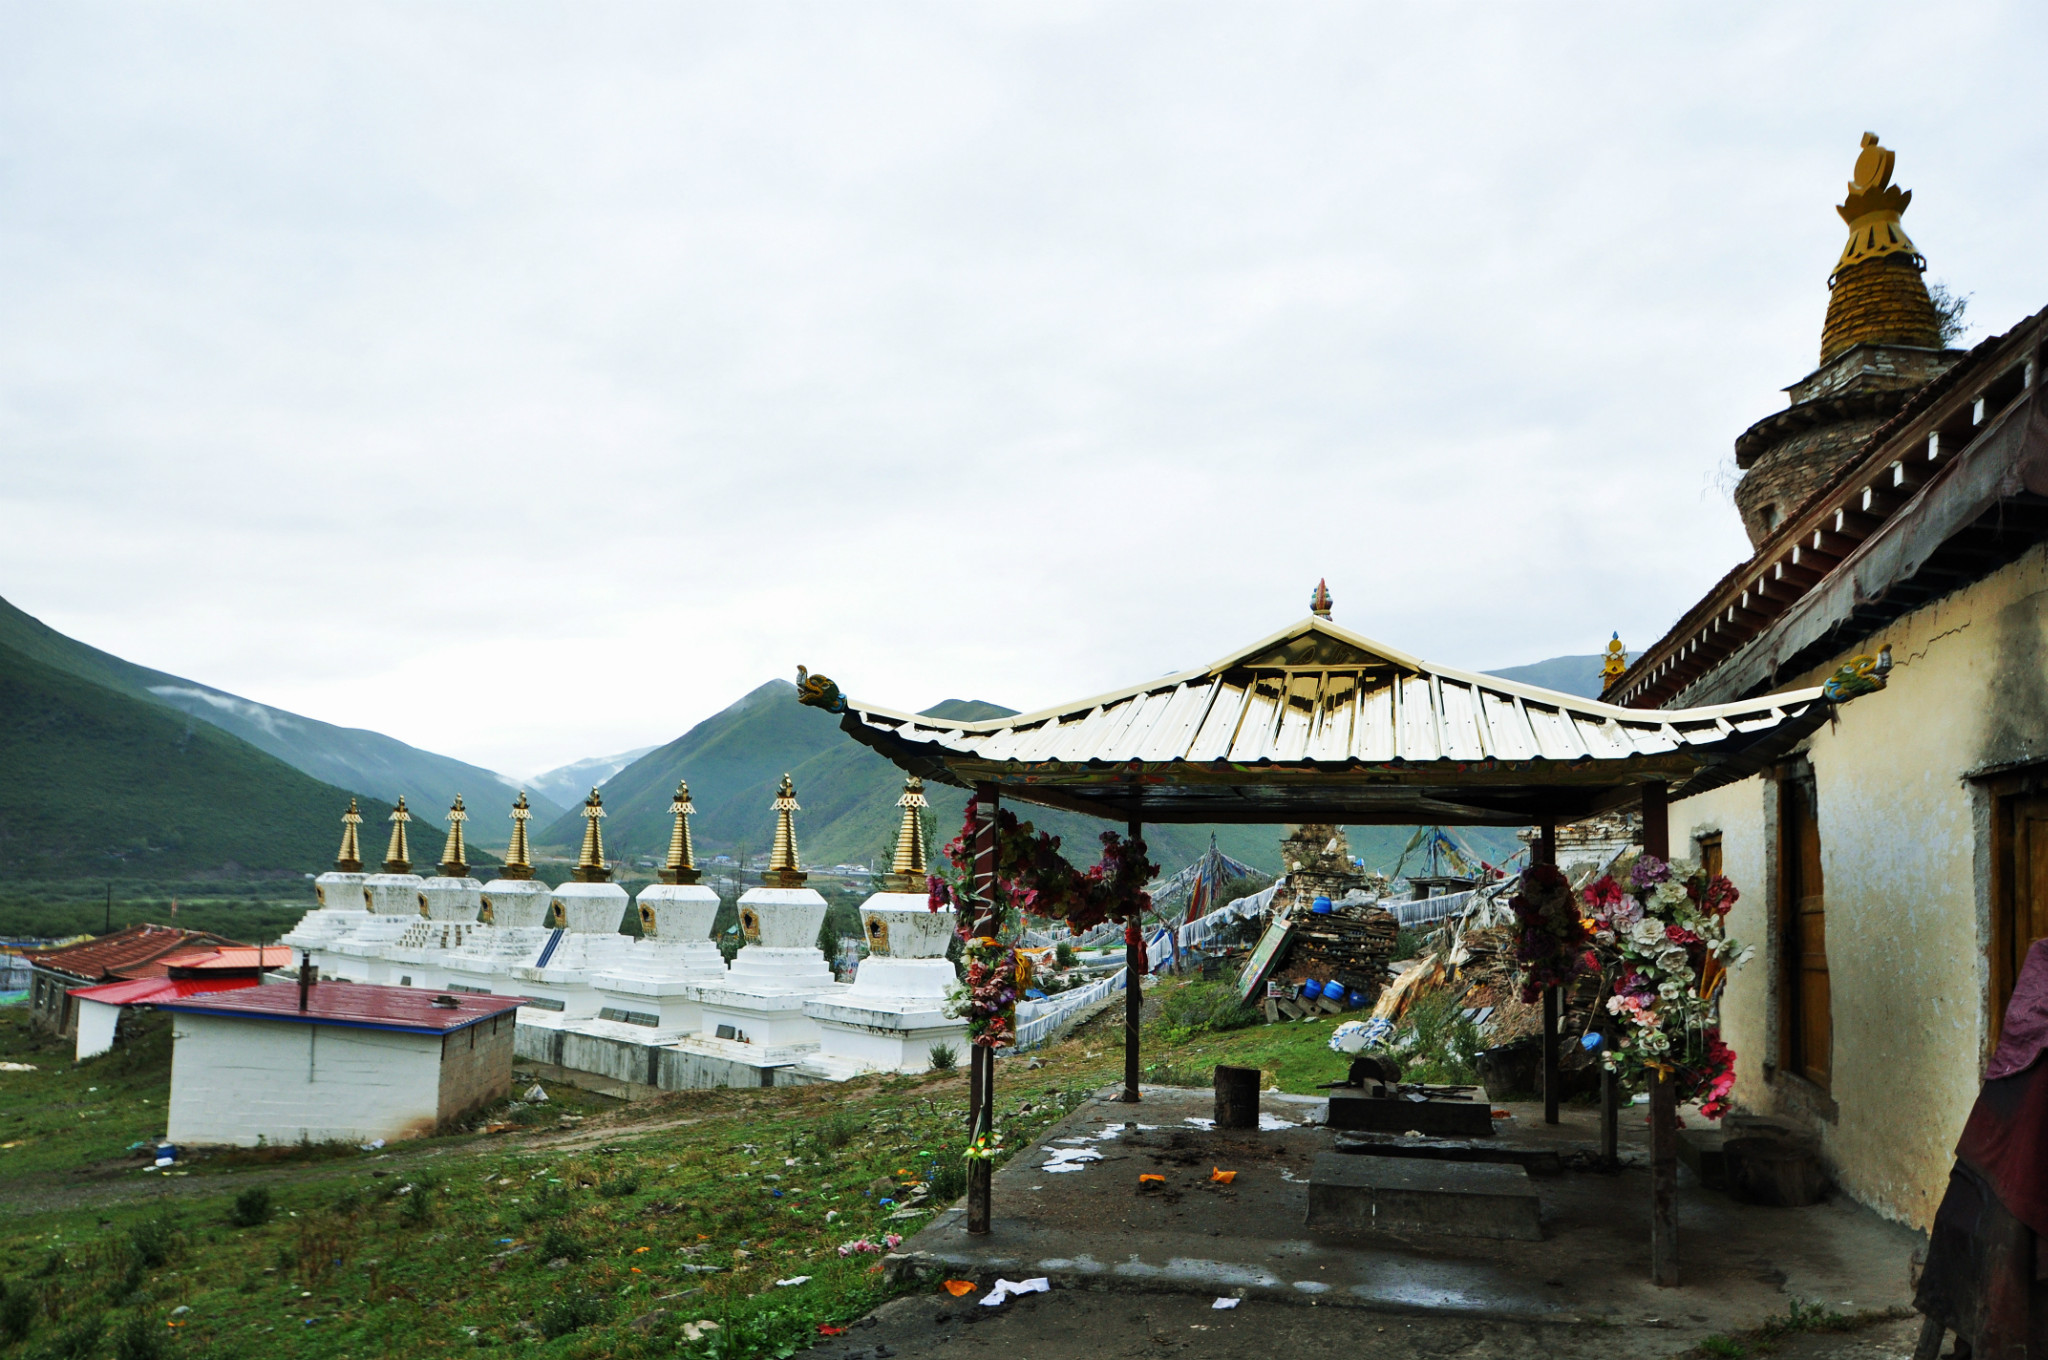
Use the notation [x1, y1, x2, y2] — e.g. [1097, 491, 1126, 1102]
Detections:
[0, 0, 2048, 774]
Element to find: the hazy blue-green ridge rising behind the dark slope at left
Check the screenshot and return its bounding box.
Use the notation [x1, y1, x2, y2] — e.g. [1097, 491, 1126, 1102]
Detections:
[0, 600, 561, 839]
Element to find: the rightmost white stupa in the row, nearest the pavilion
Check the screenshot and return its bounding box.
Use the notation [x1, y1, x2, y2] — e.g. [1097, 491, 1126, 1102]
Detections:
[801, 776, 967, 1079]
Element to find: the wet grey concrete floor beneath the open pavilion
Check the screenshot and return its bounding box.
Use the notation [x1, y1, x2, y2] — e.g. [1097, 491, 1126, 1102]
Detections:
[891, 1088, 1919, 1354]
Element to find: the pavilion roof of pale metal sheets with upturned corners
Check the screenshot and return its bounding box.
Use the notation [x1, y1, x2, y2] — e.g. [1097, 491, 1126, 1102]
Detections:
[803, 617, 1833, 825]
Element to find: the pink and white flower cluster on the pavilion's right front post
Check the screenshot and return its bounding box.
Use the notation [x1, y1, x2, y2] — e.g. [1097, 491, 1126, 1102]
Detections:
[1581, 854, 1755, 1118]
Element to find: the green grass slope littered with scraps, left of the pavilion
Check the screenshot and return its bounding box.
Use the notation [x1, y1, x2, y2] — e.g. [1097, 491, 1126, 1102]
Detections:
[0, 979, 1346, 1360]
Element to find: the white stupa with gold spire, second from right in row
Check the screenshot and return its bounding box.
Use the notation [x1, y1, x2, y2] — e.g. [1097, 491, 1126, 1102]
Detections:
[694, 774, 846, 1061]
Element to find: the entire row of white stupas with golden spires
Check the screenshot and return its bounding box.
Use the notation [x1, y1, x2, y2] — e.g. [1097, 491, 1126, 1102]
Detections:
[283, 774, 967, 1088]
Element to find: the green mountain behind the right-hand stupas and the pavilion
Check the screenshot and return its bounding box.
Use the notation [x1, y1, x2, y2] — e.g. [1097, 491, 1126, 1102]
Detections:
[537, 680, 1518, 873]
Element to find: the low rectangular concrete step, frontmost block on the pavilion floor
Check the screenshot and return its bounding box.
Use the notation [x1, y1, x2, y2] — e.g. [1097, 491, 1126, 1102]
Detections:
[1309, 1153, 1542, 1241]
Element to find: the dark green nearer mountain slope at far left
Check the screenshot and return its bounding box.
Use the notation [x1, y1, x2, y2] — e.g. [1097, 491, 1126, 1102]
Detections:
[0, 645, 421, 879]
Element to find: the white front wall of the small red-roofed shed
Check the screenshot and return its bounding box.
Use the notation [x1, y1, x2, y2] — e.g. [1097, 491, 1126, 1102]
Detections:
[168, 1014, 440, 1147]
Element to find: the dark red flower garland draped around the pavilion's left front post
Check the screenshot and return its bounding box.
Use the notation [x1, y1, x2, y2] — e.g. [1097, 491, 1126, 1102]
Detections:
[928, 799, 1159, 1049]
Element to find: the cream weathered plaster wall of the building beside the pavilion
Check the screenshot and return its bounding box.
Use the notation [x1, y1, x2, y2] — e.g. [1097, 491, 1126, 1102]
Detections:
[1671, 536, 2048, 1227]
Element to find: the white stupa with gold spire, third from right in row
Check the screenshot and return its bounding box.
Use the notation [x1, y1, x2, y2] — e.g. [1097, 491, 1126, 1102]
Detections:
[594, 782, 725, 1038]
